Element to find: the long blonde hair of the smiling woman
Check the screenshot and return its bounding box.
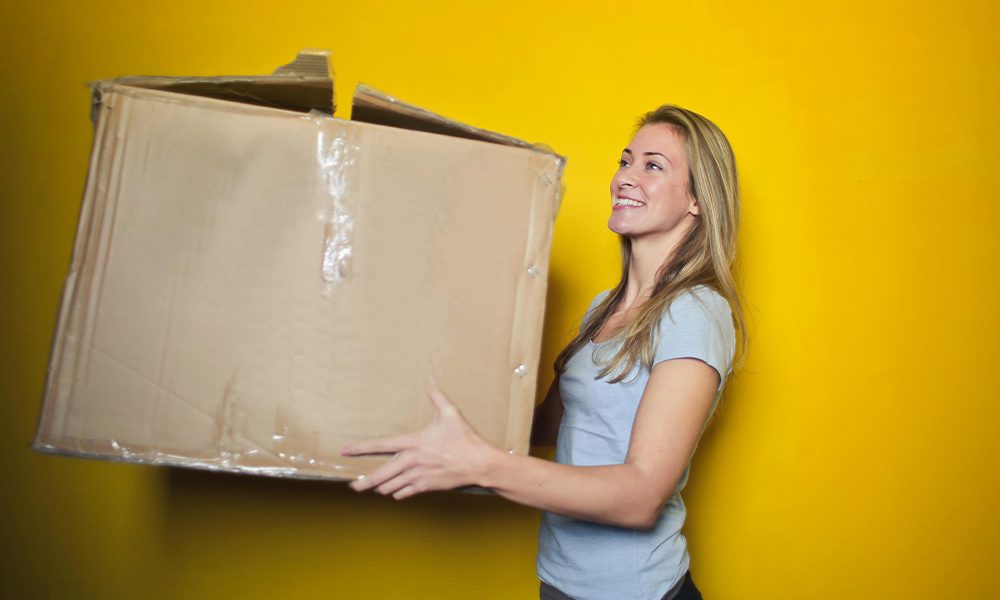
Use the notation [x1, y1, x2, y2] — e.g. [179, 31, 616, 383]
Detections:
[555, 104, 747, 383]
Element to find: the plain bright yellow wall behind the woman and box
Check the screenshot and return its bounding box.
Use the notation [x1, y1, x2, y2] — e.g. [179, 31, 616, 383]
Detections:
[0, 0, 1000, 599]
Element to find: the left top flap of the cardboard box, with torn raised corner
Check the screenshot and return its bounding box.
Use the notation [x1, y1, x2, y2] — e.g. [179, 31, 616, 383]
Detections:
[95, 49, 335, 115]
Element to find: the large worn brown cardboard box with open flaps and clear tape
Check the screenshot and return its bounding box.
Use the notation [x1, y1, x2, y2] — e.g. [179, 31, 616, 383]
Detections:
[35, 53, 564, 479]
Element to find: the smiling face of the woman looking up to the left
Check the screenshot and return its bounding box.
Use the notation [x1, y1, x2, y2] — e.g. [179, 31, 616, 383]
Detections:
[608, 123, 698, 239]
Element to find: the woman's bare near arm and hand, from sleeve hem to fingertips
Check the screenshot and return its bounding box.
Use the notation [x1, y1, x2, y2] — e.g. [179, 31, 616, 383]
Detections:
[343, 358, 719, 528]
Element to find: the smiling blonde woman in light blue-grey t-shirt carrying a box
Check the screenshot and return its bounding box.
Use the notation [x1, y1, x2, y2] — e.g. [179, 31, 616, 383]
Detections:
[344, 105, 745, 600]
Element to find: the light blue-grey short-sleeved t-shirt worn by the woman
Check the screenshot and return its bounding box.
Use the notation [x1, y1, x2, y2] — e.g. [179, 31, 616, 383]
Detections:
[537, 286, 735, 600]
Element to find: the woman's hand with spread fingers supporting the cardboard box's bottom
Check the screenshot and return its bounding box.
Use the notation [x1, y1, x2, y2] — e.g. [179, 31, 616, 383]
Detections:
[341, 384, 501, 500]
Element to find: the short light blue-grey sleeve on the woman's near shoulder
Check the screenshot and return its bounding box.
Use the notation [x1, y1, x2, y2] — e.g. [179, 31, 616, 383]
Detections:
[653, 286, 736, 389]
